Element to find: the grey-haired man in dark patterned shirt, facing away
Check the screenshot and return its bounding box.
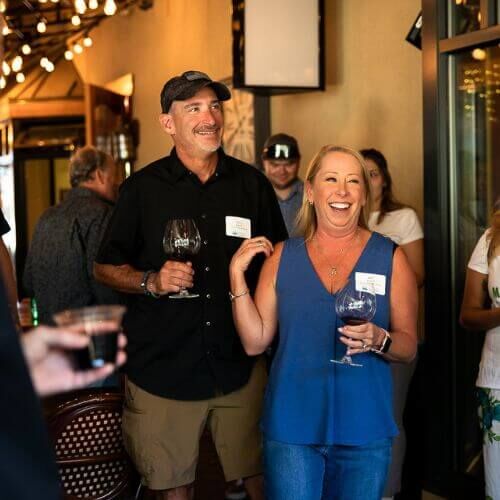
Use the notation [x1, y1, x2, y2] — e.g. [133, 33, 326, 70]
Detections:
[24, 146, 121, 324]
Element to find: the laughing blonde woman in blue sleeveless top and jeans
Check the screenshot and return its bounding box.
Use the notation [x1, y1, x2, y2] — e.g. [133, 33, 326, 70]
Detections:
[230, 146, 418, 500]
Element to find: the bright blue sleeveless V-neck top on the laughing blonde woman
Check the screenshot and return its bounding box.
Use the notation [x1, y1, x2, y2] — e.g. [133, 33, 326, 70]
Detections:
[262, 233, 397, 445]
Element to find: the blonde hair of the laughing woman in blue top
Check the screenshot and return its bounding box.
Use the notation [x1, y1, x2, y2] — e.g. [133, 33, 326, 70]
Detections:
[296, 144, 372, 241]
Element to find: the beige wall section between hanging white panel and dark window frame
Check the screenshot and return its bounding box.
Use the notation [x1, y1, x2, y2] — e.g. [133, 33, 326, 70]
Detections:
[271, 0, 423, 214]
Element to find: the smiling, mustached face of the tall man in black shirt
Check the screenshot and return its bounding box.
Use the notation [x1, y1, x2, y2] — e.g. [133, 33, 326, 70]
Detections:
[160, 87, 224, 157]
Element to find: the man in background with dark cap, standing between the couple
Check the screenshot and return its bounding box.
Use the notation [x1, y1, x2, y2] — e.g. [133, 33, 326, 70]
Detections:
[262, 134, 304, 235]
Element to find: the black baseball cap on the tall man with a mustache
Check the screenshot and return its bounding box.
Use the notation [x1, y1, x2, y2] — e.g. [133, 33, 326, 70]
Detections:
[160, 70, 231, 113]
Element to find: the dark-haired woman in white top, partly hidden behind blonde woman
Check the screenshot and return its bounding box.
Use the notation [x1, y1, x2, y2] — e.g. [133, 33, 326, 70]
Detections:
[360, 149, 424, 499]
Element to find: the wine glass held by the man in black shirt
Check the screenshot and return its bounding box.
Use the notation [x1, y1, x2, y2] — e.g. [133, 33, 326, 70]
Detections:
[163, 219, 201, 299]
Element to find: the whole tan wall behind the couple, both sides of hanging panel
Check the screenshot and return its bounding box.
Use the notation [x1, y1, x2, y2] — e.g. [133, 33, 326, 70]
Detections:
[73, 0, 422, 211]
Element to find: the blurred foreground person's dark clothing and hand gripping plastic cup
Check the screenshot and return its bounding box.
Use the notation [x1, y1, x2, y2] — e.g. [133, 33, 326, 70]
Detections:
[0, 285, 126, 500]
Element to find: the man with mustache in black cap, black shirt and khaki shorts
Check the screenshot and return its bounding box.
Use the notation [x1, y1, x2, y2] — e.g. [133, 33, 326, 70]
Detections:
[95, 71, 287, 499]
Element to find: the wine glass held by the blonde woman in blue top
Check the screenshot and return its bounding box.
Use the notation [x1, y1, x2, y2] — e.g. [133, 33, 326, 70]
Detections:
[331, 280, 377, 366]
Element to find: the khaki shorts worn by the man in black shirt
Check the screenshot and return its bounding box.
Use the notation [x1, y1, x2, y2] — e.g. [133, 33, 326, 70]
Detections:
[123, 359, 267, 490]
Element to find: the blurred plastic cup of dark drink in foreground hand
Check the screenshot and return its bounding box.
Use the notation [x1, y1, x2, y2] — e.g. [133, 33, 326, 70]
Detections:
[53, 305, 125, 368]
